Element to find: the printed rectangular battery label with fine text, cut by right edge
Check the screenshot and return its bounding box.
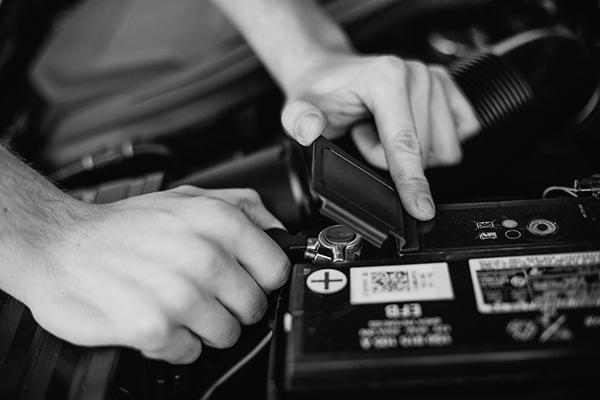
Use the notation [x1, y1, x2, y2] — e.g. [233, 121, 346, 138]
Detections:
[469, 252, 600, 314]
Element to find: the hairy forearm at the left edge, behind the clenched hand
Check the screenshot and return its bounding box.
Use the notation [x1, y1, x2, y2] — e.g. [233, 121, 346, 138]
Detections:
[0, 145, 74, 301]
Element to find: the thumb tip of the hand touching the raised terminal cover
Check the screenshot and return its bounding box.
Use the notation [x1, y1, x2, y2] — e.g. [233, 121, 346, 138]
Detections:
[281, 99, 327, 146]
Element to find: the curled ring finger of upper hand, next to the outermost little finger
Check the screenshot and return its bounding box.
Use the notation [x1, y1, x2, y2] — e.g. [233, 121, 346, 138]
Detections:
[428, 74, 462, 167]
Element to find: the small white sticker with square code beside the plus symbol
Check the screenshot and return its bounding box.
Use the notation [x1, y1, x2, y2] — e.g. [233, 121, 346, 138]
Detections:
[350, 263, 454, 304]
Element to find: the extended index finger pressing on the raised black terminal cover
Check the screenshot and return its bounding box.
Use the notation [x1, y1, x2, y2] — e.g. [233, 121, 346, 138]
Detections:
[363, 60, 435, 220]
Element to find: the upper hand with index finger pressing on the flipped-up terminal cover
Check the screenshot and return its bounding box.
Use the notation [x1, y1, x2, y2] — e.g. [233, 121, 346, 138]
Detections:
[282, 54, 479, 220]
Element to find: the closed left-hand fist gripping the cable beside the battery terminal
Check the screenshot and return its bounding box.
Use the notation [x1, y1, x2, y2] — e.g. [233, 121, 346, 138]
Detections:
[23, 186, 290, 363]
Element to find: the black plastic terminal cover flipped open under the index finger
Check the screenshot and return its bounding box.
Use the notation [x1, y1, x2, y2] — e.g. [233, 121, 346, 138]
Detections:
[311, 137, 418, 251]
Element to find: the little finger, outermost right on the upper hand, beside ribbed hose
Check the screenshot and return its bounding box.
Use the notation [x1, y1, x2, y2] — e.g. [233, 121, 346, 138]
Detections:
[429, 65, 481, 141]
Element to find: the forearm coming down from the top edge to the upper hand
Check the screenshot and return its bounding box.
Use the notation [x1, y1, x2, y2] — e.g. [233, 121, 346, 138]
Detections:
[212, 0, 352, 94]
